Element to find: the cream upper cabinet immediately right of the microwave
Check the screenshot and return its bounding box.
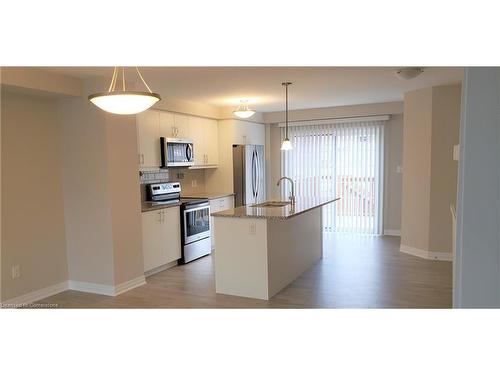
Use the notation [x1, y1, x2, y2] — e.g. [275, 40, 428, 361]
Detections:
[189, 117, 219, 166]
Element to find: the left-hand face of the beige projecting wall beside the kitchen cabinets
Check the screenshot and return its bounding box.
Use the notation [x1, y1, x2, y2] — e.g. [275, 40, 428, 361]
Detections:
[59, 93, 114, 285]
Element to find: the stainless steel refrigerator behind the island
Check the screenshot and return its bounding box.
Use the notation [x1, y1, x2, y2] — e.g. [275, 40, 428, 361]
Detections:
[233, 145, 266, 207]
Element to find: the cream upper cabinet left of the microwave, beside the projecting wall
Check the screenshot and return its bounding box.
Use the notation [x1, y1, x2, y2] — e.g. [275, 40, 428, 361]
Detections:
[136, 111, 161, 168]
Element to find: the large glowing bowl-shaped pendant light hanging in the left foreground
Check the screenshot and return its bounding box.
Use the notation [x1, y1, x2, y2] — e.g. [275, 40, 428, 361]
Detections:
[89, 67, 161, 115]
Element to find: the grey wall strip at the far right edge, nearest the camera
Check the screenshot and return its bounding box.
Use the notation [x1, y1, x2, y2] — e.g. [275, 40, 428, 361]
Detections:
[453, 68, 500, 308]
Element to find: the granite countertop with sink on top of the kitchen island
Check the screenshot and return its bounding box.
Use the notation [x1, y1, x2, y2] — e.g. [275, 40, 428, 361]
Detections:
[212, 197, 340, 220]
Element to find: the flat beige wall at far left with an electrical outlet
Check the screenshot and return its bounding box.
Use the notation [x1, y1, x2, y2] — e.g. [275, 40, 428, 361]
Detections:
[1, 87, 68, 301]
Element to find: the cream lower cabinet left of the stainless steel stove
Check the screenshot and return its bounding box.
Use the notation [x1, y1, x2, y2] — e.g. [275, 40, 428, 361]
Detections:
[142, 207, 181, 272]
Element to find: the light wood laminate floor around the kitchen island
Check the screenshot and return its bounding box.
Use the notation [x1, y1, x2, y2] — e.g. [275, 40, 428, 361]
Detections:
[37, 234, 452, 308]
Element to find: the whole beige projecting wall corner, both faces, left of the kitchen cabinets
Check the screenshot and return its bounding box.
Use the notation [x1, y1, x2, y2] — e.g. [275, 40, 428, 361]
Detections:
[59, 82, 143, 286]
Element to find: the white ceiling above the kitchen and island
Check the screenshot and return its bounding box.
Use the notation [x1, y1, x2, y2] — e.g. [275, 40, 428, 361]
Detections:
[45, 67, 463, 112]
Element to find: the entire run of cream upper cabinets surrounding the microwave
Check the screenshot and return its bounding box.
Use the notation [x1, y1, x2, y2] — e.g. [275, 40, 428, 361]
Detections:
[136, 110, 219, 168]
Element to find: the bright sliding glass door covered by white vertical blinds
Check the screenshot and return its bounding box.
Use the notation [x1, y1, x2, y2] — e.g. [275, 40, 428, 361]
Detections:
[282, 121, 384, 234]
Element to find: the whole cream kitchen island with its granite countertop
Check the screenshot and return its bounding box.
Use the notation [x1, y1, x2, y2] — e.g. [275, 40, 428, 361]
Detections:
[212, 197, 339, 300]
